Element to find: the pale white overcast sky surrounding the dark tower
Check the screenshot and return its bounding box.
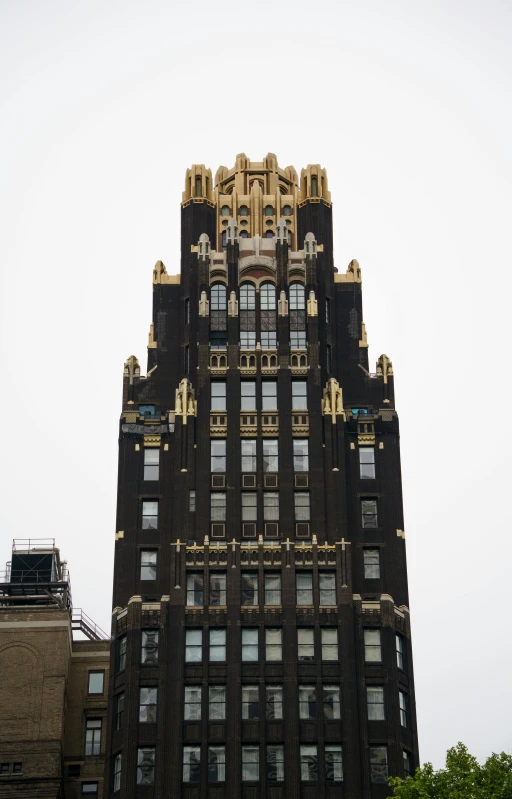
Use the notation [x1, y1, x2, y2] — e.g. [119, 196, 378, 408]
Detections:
[0, 0, 512, 767]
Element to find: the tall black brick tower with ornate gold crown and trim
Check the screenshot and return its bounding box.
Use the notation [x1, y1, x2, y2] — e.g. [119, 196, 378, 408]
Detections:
[107, 154, 418, 799]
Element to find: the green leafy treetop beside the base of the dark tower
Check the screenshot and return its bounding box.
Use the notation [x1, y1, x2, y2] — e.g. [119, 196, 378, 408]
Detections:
[389, 743, 512, 799]
